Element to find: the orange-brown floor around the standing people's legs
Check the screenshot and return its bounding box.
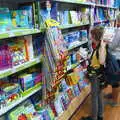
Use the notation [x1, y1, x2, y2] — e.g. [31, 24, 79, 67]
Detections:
[71, 86, 120, 120]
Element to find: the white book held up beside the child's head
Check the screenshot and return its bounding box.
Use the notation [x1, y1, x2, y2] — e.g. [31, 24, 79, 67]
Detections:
[102, 27, 115, 42]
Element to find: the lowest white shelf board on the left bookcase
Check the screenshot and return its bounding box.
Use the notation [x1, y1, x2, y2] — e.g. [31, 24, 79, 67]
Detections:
[0, 87, 41, 116]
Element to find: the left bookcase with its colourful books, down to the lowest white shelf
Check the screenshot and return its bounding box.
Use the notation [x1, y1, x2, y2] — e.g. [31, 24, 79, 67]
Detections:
[0, 0, 44, 120]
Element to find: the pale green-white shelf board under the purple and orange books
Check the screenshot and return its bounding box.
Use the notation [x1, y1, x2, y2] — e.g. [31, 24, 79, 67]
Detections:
[0, 55, 42, 79]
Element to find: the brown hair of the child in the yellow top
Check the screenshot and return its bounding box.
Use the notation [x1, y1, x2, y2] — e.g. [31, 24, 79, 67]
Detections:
[91, 26, 104, 41]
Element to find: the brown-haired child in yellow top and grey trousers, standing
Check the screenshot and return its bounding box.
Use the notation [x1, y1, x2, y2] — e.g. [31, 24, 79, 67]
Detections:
[83, 26, 107, 120]
